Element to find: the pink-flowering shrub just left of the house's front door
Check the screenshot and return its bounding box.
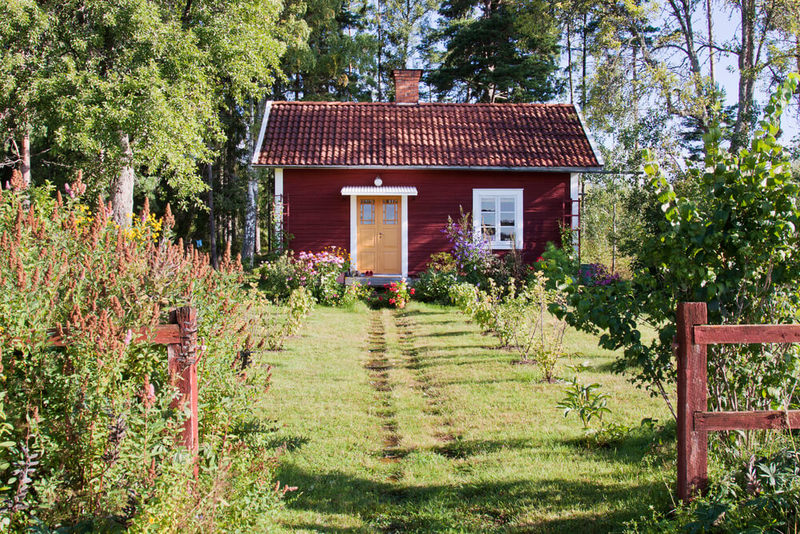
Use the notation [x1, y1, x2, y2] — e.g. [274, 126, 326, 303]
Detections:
[259, 248, 350, 305]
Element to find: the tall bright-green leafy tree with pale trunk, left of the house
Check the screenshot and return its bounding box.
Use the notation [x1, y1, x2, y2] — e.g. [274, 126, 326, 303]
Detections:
[3, 0, 287, 224]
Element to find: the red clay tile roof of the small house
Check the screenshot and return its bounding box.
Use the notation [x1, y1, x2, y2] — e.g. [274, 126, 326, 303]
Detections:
[253, 102, 600, 168]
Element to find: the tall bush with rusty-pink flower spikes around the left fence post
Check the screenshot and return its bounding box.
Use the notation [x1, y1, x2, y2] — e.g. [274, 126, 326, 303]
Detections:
[0, 185, 300, 532]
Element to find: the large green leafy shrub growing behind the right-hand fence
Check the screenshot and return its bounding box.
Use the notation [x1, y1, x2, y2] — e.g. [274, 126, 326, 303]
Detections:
[543, 76, 800, 418]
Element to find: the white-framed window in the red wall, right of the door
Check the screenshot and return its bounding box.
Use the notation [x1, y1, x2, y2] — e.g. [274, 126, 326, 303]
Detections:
[472, 189, 523, 250]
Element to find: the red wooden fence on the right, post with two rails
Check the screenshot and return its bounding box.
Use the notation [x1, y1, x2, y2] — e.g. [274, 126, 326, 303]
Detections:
[677, 302, 800, 502]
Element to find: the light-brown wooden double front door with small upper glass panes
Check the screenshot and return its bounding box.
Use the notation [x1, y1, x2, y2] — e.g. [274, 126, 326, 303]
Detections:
[356, 197, 401, 274]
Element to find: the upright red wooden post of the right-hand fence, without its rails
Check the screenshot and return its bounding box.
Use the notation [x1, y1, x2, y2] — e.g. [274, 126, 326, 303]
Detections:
[677, 302, 708, 502]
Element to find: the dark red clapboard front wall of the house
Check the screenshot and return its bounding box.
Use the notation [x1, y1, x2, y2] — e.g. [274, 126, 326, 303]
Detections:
[283, 169, 572, 274]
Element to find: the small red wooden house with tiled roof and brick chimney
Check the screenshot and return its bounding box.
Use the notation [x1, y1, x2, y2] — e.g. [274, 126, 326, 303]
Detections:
[252, 70, 602, 276]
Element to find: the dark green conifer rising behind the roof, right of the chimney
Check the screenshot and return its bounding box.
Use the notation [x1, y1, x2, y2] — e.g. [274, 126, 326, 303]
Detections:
[428, 0, 558, 102]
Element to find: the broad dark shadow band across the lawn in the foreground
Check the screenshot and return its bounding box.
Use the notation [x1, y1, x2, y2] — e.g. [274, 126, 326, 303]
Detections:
[277, 462, 667, 534]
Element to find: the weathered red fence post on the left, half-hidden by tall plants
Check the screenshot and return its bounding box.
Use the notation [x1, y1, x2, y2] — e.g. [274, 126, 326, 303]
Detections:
[167, 306, 199, 456]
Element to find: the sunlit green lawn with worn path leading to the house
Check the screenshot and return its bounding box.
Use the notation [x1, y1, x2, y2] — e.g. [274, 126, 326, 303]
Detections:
[264, 303, 674, 533]
